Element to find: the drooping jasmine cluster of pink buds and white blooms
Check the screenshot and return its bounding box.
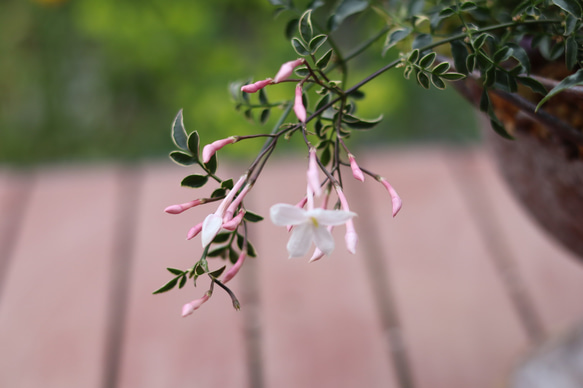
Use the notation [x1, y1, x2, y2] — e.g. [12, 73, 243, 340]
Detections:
[155, 47, 401, 317]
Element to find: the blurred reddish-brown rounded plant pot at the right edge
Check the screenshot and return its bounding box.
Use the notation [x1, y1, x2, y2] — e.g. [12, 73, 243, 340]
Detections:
[456, 67, 583, 262]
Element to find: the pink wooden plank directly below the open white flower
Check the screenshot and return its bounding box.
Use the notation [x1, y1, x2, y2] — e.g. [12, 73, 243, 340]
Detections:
[249, 159, 396, 388]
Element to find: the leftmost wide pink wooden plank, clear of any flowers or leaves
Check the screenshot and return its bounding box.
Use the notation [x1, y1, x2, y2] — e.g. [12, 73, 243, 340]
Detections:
[0, 168, 116, 388]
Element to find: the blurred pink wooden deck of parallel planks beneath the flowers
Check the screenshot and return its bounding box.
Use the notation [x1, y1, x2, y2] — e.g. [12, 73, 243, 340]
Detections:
[0, 148, 583, 388]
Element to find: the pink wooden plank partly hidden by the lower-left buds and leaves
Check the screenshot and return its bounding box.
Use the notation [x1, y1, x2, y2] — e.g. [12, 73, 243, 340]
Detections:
[119, 162, 248, 388]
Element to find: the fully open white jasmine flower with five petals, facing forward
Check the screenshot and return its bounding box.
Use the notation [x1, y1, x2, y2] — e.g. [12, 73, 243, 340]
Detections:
[270, 203, 356, 258]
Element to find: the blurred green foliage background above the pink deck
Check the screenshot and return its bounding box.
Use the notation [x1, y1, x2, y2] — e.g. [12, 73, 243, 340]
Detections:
[0, 0, 477, 165]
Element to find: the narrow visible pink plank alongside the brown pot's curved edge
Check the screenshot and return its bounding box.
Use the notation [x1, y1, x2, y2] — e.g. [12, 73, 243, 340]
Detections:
[476, 151, 583, 336]
